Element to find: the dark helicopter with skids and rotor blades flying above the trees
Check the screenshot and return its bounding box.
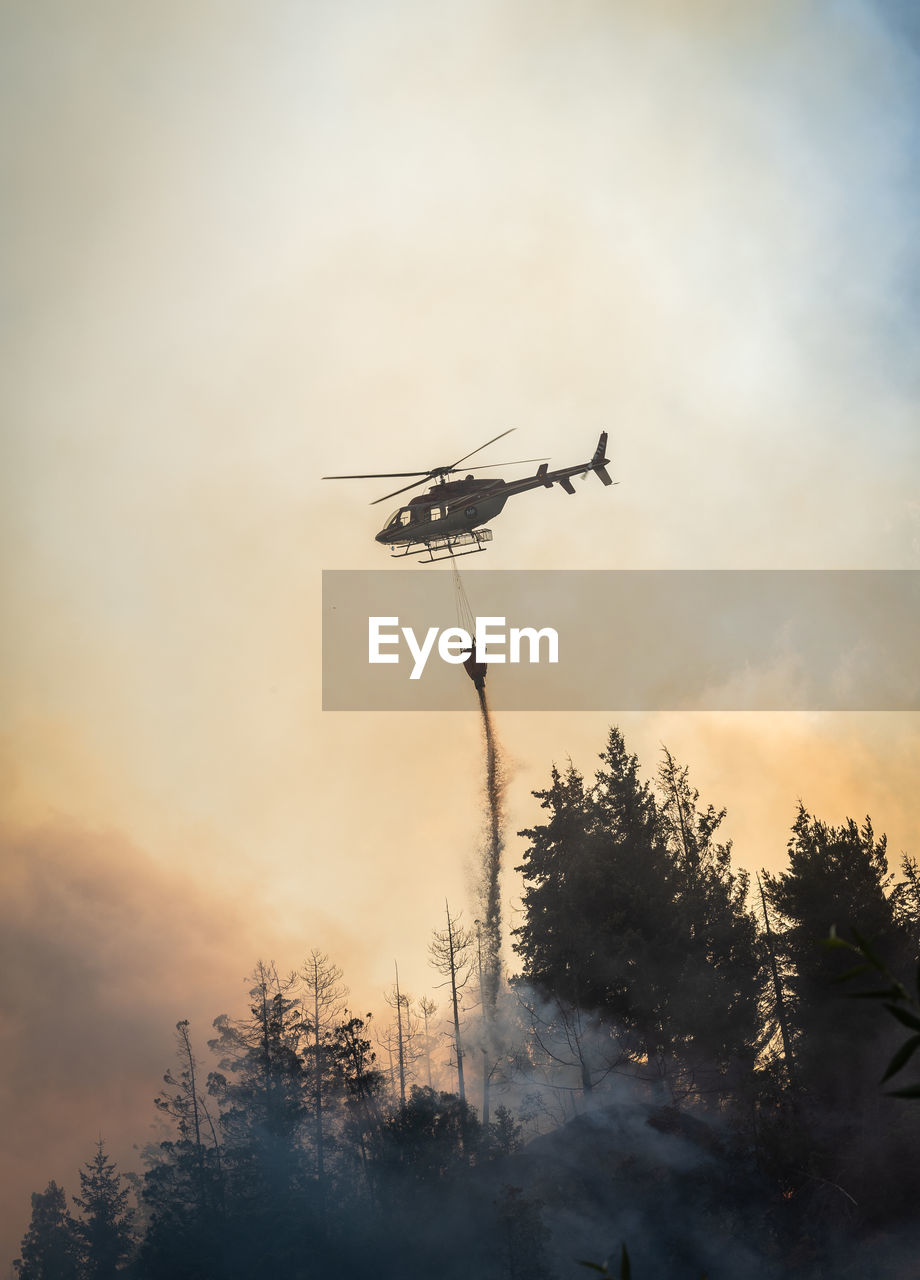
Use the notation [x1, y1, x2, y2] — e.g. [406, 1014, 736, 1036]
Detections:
[322, 426, 615, 564]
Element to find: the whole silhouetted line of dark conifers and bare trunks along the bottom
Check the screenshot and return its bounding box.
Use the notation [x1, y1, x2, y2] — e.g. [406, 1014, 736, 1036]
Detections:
[14, 728, 920, 1280]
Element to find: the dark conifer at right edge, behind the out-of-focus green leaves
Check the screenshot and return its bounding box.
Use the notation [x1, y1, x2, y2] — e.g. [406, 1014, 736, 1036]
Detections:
[765, 805, 920, 1226]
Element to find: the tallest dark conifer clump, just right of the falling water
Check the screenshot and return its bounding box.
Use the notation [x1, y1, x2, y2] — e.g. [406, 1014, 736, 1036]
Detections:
[514, 728, 761, 1096]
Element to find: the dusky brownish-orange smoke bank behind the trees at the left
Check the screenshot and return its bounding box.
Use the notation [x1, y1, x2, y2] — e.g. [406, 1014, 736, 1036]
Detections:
[0, 818, 345, 1266]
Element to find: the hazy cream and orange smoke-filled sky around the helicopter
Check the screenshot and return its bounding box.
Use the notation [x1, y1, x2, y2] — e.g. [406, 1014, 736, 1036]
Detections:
[0, 0, 920, 1256]
